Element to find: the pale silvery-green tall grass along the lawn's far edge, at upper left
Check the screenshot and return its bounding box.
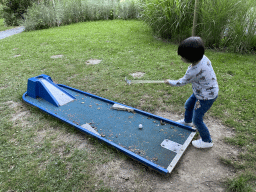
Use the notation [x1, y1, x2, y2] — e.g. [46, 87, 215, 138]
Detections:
[24, 0, 139, 31]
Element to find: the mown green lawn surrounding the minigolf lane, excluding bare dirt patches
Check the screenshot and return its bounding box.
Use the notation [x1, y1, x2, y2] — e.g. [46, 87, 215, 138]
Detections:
[0, 20, 256, 191]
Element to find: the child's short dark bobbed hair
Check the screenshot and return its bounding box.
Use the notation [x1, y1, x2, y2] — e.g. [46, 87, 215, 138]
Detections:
[178, 37, 204, 63]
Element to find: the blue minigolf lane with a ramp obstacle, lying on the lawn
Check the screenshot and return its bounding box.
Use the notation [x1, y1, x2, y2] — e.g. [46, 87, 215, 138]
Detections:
[23, 74, 196, 174]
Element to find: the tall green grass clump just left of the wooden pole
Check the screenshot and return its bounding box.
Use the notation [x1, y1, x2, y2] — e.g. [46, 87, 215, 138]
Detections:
[141, 0, 194, 41]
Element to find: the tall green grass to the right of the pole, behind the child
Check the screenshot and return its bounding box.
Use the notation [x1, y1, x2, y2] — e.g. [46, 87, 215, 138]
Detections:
[198, 0, 256, 52]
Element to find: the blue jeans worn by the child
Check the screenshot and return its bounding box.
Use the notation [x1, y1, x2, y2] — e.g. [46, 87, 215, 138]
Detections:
[184, 94, 217, 142]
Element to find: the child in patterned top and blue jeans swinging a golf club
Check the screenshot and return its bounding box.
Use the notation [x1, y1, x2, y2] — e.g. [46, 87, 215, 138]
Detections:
[165, 37, 219, 148]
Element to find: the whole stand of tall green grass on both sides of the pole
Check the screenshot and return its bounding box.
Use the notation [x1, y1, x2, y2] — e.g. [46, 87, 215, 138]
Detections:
[141, 0, 256, 52]
